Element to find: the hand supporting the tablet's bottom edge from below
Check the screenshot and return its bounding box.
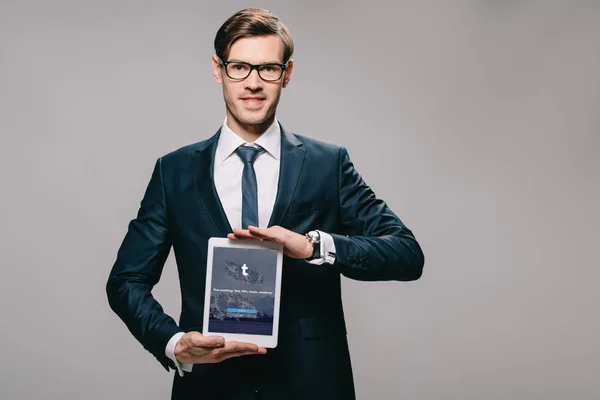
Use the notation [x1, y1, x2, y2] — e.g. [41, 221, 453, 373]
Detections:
[175, 332, 267, 364]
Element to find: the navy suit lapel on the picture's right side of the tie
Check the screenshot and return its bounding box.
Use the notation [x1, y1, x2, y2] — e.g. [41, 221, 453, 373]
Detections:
[268, 125, 306, 226]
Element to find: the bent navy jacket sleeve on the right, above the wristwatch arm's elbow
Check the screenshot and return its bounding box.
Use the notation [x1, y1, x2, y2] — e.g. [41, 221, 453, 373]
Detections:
[332, 148, 424, 281]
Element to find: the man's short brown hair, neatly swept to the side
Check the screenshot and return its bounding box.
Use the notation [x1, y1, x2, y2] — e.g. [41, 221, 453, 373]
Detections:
[215, 8, 294, 64]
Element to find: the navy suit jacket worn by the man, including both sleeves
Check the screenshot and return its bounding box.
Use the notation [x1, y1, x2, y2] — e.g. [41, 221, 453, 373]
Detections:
[106, 127, 424, 400]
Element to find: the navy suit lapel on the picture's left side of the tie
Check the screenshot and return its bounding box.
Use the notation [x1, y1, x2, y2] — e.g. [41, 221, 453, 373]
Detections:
[193, 129, 233, 237]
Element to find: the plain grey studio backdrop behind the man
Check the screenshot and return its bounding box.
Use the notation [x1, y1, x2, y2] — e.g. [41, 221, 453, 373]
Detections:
[0, 0, 600, 399]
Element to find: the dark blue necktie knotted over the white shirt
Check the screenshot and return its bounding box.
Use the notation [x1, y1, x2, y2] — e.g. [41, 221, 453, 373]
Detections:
[235, 145, 263, 229]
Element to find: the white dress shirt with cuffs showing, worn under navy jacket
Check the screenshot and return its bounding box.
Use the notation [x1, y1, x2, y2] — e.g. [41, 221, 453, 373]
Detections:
[165, 118, 335, 376]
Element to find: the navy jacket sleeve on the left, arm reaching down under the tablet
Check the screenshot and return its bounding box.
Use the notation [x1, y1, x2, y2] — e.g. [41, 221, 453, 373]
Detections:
[106, 159, 181, 370]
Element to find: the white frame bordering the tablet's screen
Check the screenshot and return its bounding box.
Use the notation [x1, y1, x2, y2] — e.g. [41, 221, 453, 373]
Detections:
[202, 237, 283, 348]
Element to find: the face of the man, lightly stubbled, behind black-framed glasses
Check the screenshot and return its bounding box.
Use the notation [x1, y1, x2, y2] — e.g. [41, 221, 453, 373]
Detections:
[212, 35, 293, 130]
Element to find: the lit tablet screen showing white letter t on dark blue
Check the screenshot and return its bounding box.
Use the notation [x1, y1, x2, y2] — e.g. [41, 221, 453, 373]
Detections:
[208, 247, 277, 335]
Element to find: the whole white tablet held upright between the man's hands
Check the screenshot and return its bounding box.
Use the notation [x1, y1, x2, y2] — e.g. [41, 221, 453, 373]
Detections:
[202, 238, 283, 348]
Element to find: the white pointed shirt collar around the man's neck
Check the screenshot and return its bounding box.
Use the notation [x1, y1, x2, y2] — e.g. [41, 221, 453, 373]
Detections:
[216, 117, 281, 161]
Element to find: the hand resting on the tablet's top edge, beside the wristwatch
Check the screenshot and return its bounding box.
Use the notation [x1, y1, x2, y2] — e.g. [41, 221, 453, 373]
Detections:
[227, 226, 313, 258]
